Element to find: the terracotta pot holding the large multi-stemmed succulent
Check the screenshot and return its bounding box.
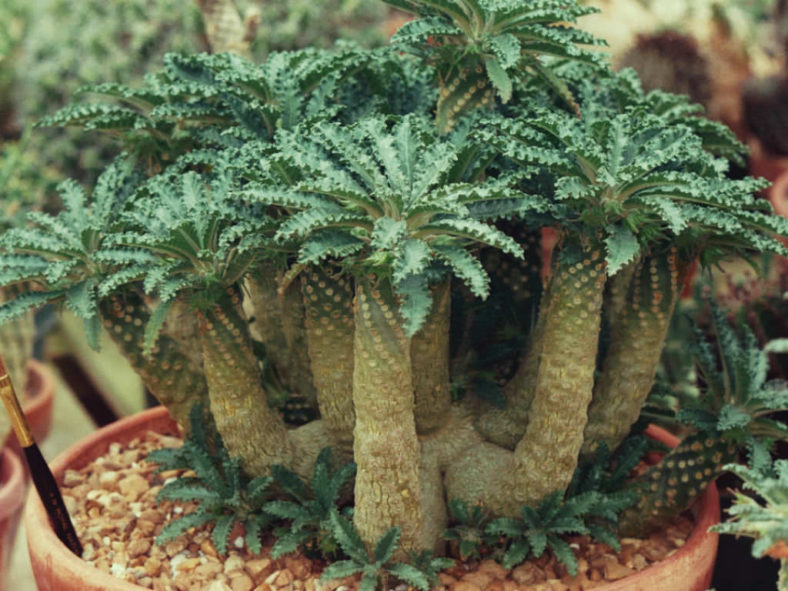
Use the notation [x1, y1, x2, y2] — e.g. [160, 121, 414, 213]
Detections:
[25, 407, 720, 591]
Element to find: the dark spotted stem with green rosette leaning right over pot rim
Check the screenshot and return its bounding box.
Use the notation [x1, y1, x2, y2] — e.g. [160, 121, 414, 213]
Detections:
[619, 306, 788, 535]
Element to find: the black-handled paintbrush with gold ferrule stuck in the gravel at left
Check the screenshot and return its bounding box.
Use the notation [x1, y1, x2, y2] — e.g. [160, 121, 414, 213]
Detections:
[0, 356, 82, 557]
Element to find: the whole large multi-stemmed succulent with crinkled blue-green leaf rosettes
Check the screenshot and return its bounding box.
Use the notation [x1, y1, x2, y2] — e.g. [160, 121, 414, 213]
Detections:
[0, 0, 788, 587]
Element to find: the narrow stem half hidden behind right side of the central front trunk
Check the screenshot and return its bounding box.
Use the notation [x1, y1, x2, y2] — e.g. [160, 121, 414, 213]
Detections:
[410, 280, 451, 435]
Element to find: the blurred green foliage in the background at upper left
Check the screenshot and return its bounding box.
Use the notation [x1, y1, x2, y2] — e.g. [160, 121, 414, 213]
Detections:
[0, 0, 396, 210]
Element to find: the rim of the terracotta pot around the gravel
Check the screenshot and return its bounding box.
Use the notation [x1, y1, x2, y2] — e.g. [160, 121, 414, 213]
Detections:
[24, 407, 720, 591]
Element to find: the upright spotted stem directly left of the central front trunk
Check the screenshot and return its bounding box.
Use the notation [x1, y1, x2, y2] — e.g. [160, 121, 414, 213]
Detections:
[302, 268, 356, 452]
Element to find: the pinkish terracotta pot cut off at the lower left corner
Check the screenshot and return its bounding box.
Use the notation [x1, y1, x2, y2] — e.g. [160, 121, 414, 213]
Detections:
[0, 448, 25, 591]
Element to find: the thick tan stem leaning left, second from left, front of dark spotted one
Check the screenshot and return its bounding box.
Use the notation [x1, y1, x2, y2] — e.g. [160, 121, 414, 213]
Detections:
[198, 288, 293, 476]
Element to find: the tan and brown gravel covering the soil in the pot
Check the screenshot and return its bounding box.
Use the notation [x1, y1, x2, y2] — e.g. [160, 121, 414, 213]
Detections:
[62, 432, 693, 591]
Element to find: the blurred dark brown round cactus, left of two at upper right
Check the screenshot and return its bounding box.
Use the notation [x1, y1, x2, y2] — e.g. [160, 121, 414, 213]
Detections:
[618, 31, 711, 105]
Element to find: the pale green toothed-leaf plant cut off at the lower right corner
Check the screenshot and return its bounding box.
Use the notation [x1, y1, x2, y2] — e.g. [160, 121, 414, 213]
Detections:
[712, 458, 788, 590]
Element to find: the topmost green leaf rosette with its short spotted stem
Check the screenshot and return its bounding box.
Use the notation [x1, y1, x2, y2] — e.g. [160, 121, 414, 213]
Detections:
[386, 0, 604, 131]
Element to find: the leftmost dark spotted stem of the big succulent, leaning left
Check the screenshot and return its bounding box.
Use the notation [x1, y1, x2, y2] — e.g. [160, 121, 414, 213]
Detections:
[100, 291, 208, 432]
